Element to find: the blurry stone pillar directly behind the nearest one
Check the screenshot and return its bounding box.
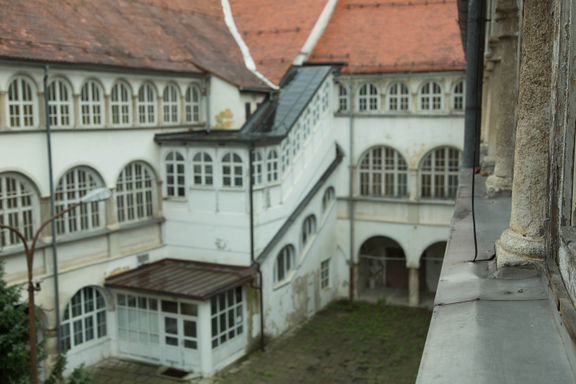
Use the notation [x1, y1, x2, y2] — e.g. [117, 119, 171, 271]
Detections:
[486, 0, 518, 196]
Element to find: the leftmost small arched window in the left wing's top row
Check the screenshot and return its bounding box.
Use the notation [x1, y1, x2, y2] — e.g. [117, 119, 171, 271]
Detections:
[6, 75, 38, 129]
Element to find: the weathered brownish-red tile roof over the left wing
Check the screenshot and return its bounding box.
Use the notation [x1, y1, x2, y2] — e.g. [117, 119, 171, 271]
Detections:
[0, 0, 263, 87]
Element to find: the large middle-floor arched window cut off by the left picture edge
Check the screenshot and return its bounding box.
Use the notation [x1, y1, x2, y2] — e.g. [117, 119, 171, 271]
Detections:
[0, 173, 40, 249]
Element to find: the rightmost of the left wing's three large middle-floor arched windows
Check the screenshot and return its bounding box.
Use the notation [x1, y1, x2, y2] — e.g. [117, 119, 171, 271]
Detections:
[116, 161, 156, 223]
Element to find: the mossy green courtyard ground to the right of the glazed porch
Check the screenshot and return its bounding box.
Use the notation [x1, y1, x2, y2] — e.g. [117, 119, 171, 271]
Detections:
[213, 301, 432, 384]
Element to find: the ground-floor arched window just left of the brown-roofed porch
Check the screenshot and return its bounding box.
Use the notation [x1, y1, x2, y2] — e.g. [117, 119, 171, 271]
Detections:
[61, 286, 109, 351]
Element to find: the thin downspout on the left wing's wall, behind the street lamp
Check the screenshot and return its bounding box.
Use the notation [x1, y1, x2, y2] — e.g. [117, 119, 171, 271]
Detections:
[44, 64, 62, 355]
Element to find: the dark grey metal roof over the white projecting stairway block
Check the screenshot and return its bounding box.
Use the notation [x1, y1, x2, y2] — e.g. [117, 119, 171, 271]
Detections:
[154, 66, 332, 144]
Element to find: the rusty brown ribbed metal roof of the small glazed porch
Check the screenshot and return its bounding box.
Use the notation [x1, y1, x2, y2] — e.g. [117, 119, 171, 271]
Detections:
[104, 259, 256, 300]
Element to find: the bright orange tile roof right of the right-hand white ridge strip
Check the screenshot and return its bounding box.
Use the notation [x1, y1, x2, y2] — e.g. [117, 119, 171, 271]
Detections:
[309, 0, 465, 73]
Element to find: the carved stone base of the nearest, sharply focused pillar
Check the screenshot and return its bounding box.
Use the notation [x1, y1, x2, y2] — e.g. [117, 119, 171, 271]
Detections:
[496, 229, 546, 268]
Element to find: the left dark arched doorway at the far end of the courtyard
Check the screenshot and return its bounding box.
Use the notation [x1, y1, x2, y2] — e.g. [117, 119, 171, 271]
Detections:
[358, 236, 408, 293]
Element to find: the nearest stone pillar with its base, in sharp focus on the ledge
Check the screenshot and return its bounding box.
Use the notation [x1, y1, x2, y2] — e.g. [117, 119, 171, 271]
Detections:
[496, 0, 552, 266]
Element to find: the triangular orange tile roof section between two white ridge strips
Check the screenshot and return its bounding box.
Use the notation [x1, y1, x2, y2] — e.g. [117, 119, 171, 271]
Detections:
[230, 0, 327, 84]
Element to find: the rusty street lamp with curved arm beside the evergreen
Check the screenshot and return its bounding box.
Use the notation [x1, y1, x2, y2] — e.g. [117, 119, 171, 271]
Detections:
[0, 188, 112, 384]
